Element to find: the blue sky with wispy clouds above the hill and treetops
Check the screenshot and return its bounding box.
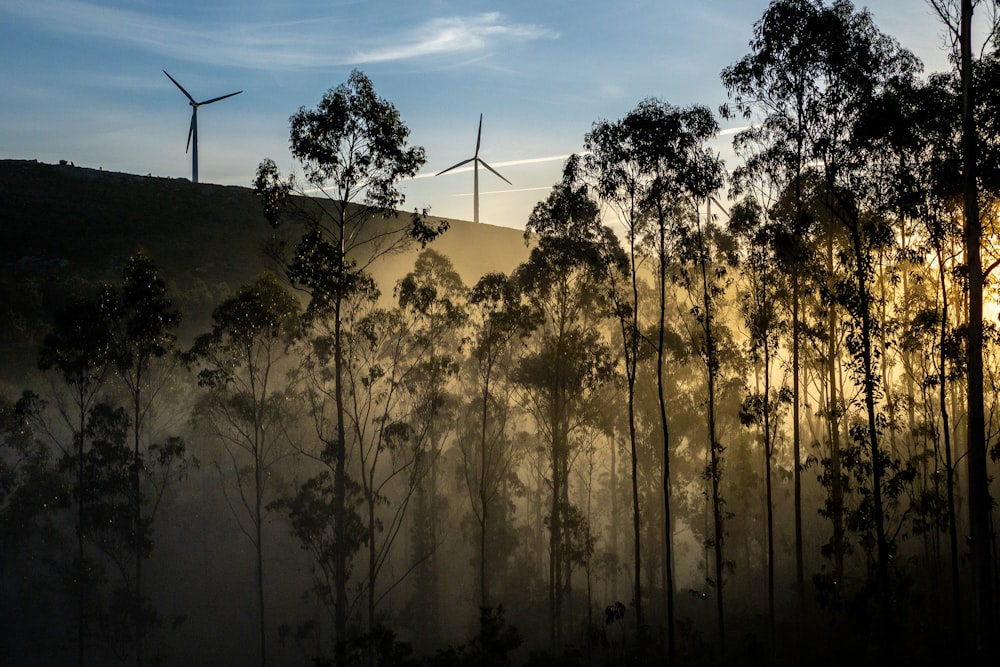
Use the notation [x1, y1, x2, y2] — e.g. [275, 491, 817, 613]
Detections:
[0, 0, 968, 227]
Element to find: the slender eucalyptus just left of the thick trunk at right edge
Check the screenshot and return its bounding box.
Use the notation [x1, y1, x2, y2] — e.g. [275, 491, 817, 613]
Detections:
[871, 47, 1000, 647]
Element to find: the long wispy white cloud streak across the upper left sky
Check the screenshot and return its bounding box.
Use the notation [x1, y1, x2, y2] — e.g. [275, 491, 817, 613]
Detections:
[0, 0, 559, 70]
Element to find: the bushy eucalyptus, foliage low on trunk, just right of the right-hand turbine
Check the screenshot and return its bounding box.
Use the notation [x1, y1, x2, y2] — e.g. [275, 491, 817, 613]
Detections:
[513, 156, 612, 643]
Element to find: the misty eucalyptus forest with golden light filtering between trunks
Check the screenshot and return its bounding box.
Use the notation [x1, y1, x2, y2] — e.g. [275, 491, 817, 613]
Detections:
[0, 0, 1000, 666]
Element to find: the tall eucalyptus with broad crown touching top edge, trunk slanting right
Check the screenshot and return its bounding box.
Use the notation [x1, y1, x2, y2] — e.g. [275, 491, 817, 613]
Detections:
[724, 0, 918, 636]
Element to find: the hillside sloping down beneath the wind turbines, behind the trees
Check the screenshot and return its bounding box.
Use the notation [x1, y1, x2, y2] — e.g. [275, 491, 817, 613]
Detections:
[0, 160, 528, 379]
